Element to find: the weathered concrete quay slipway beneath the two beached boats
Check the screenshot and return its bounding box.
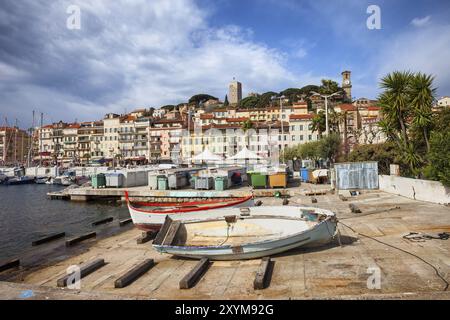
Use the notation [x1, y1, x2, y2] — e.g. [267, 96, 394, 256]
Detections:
[0, 184, 450, 300]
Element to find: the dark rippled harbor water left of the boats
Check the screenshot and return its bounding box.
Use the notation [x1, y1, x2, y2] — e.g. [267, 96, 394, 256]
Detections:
[0, 184, 129, 261]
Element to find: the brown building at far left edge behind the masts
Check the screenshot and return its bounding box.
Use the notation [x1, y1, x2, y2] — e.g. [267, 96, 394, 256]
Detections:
[0, 127, 31, 165]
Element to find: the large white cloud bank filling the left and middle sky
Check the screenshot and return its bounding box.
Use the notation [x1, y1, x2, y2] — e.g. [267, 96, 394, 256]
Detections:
[0, 0, 320, 127]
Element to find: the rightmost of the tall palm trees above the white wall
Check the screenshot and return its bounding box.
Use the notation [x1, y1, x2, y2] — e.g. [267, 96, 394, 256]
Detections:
[411, 72, 436, 152]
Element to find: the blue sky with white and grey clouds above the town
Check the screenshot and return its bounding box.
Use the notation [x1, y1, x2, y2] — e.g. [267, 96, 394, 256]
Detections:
[0, 0, 450, 128]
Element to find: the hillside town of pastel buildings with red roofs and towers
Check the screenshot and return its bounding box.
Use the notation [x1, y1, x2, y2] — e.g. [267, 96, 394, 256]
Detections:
[0, 71, 385, 166]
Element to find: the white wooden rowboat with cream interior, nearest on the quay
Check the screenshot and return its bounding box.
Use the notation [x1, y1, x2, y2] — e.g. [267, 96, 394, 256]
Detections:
[153, 206, 337, 260]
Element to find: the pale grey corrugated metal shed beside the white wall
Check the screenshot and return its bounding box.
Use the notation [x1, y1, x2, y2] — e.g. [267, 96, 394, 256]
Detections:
[334, 161, 378, 190]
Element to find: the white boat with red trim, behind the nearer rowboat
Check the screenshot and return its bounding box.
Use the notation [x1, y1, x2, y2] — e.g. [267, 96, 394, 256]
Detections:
[125, 191, 254, 231]
